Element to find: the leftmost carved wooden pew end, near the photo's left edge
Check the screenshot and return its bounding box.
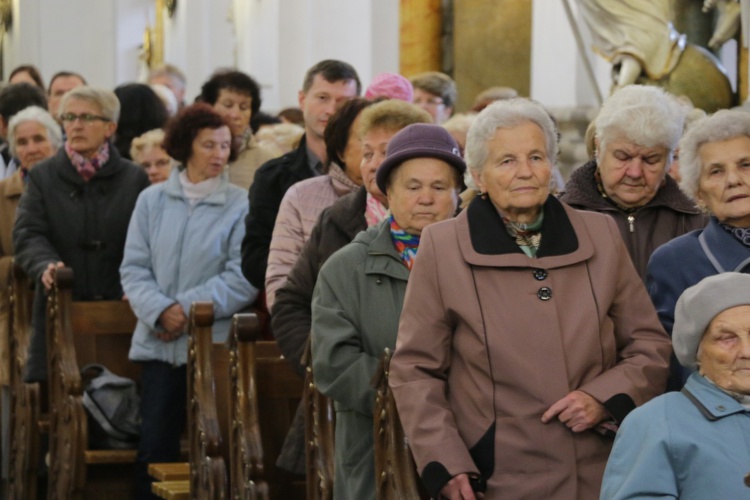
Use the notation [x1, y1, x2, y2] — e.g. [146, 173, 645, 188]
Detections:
[2, 264, 40, 500]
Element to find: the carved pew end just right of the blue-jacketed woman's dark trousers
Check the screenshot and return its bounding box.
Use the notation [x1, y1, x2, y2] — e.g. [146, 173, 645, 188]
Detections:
[187, 302, 228, 500]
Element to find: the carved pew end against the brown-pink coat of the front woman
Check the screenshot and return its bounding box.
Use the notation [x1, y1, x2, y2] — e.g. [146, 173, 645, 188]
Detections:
[373, 349, 429, 500]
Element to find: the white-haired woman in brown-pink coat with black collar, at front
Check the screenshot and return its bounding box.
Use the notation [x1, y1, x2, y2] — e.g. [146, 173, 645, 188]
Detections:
[390, 99, 670, 500]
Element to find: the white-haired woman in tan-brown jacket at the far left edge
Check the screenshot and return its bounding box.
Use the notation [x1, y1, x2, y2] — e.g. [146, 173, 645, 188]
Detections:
[0, 106, 62, 383]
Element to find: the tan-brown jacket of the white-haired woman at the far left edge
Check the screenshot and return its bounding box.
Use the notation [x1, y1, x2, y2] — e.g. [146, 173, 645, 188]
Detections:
[0, 170, 24, 384]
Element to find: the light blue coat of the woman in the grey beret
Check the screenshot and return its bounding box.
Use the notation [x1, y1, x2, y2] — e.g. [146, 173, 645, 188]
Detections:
[600, 373, 750, 500]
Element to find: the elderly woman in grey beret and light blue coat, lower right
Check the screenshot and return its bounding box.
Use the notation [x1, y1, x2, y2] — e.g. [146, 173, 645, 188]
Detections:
[601, 272, 750, 500]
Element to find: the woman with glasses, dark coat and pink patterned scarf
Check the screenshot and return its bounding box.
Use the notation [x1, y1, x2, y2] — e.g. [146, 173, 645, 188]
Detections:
[13, 86, 149, 381]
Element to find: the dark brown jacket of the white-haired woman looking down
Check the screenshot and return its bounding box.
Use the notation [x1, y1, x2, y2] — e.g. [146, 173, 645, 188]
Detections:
[560, 161, 708, 279]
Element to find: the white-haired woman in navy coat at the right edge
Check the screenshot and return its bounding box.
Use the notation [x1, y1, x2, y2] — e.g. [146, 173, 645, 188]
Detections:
[646, 110, 750, 390]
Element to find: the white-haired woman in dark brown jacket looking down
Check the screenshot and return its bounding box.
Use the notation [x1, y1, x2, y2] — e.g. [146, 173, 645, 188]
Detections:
[560, 85, 706, 278]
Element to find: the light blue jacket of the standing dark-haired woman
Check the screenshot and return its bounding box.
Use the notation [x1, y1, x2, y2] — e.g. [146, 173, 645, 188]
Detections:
[120, 168, 258, 365]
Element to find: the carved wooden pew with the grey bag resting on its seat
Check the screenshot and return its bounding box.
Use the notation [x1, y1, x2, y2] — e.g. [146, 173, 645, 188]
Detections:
[47, 268, 140, 500]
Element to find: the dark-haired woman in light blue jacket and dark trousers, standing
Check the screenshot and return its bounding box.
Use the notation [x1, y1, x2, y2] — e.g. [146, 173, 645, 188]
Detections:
[120, 104, 257, 498]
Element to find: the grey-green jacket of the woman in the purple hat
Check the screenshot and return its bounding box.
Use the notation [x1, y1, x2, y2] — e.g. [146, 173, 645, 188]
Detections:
[311, 220, 409, 499]
